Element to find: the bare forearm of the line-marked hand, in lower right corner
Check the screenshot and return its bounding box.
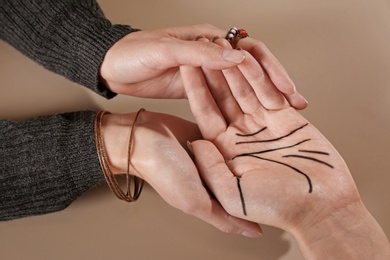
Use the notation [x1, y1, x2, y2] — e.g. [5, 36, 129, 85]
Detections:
[293, 202, 390, 260]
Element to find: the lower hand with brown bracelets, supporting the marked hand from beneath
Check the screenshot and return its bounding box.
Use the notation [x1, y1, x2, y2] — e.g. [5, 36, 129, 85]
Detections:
[102, 111, 261, 237]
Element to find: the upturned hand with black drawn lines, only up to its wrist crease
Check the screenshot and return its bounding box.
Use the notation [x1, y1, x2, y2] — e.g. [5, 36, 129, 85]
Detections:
[181, 63, 359, 232]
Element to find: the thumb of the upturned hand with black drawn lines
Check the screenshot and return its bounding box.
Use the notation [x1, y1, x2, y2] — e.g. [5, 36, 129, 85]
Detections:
[191, 140, 247, 218]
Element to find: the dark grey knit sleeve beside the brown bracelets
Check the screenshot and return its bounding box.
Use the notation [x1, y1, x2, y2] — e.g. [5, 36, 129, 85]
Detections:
[0, 112, 105, 220]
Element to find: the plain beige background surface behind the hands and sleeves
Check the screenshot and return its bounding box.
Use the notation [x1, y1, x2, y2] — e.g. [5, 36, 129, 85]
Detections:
[0, 0, 390, 260]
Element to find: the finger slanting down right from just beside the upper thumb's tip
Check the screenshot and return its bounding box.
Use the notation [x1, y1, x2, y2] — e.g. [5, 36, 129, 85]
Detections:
[238, 50, 289, 110]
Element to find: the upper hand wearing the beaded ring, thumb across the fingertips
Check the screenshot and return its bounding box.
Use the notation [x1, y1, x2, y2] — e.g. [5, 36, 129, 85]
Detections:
[100, 25, 307, 109]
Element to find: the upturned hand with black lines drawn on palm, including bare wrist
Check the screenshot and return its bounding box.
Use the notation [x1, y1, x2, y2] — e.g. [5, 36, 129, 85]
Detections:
[181, 66, 390, 259]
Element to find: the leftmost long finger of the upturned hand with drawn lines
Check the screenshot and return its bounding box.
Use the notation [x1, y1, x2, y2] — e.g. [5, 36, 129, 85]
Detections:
[180, 66, 227, 140]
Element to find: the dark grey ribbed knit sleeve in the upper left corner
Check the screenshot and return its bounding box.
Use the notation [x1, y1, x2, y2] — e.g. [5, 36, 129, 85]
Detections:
[0, 0, 137, 98]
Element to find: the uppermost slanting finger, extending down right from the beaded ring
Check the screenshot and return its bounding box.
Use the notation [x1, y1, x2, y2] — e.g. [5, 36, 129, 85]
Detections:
[237, 37, 296, 95]
